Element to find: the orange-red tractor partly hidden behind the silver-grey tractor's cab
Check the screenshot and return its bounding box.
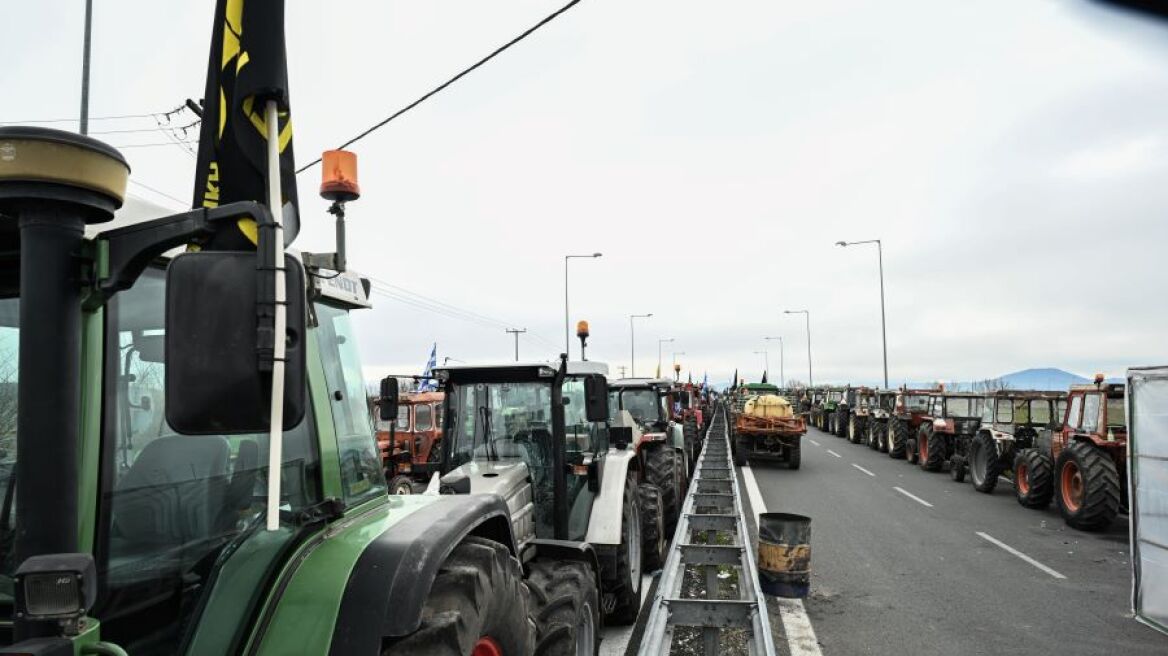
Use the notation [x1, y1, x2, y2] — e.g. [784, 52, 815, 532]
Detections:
[375, 392, 445, 494]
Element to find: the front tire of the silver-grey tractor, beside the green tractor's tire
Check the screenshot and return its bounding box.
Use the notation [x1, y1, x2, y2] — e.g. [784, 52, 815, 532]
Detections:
[530, 558, 600, 656]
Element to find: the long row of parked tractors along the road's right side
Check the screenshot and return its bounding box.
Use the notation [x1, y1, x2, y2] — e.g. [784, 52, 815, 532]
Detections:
[739, 376, 1128, 530]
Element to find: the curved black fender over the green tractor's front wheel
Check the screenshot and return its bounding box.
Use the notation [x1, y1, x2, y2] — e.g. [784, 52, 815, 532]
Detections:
[329, 494, 517, 656]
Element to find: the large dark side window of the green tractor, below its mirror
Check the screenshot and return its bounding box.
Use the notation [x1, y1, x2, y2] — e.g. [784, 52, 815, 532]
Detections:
[96, 263, 322, 655]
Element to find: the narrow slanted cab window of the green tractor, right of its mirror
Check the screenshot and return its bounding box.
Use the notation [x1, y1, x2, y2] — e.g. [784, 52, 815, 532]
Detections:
[314, 303, 385, 505]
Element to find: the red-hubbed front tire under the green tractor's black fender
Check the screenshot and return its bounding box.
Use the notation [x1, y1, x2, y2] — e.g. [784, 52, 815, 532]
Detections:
[382, 536, 534, 656]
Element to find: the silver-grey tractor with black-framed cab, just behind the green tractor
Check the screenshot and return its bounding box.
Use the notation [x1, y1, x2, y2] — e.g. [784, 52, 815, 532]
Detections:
[434, 357, 667, 639]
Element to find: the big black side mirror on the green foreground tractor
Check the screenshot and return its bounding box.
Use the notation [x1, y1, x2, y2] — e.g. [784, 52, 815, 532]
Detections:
[166, 251, 307, 435]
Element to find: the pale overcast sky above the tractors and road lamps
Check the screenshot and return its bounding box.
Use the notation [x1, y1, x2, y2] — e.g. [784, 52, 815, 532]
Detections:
[0, 0, 1168, 384]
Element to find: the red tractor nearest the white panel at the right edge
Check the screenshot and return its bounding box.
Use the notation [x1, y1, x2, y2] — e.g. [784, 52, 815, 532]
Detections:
[1014, 375, 1127, 531]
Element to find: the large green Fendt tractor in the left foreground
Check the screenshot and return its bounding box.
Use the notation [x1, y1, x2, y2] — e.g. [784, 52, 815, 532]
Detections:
[0, 127, 536, 656]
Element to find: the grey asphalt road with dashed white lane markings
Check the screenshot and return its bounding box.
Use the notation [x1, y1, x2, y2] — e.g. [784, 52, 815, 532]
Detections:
[741, 428, 1168, 656]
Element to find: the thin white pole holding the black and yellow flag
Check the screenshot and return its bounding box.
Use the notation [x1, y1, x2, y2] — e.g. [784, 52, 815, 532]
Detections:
[264, 100, 287, 531]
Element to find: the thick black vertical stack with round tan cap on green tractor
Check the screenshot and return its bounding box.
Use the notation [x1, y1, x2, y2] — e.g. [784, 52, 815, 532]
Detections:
[0, 127, 130, 640]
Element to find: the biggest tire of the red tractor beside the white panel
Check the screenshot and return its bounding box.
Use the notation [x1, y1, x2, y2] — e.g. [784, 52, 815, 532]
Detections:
[1055, 441, 1120, 531]
